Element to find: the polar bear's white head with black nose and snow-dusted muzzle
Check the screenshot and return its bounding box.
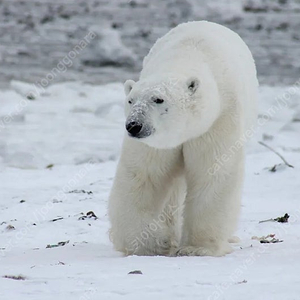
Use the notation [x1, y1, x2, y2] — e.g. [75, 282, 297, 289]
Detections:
[124, 76, 220, 149]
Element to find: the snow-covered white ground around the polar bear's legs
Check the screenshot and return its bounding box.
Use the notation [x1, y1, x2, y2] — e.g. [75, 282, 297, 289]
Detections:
[0, 82, 300, 300]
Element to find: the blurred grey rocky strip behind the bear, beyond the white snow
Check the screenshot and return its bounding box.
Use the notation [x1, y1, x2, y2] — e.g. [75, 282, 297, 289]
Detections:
[0, 0, 300, 87]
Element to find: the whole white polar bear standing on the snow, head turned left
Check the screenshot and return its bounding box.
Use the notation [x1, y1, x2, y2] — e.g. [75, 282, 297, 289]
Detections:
[109, 21, 258, 256]
